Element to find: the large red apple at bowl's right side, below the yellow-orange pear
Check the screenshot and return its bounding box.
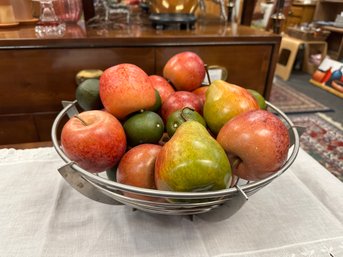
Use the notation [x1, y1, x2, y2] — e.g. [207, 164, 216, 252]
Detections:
[217, 110, 290, 181]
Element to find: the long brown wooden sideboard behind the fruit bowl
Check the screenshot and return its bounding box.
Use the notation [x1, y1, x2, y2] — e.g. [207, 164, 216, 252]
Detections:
[0, 24, 281, 145]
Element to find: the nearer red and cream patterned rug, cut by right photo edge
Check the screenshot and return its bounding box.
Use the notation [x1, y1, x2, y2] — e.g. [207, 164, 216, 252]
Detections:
[289, 113, 343, 182]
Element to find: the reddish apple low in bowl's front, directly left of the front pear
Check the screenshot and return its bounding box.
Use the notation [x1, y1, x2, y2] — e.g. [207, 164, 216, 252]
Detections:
[117, 144, 162, 200]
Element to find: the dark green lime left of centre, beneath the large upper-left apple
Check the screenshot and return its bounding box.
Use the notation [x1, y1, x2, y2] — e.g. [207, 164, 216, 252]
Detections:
[123, 111, 164, 146]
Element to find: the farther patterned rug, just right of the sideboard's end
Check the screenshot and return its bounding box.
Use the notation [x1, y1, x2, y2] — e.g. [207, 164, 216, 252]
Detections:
[269, 80, 331, 114]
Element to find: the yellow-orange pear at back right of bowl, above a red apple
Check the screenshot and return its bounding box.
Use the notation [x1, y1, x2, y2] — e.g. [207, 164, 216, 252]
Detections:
[203, 80, 259, 134]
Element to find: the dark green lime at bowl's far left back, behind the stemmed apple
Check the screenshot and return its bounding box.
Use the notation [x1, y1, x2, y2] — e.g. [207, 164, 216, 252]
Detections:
[75, 79, 103, 111]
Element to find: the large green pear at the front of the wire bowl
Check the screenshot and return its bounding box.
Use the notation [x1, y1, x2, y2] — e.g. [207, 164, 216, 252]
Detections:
[155, 120, 232, 192]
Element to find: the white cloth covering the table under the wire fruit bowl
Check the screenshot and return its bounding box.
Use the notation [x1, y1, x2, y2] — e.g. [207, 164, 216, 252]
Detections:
[0, 148, 343, 257]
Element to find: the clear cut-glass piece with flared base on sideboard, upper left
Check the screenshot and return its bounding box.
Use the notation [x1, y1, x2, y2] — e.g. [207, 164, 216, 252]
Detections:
[34, 0, 66, 37]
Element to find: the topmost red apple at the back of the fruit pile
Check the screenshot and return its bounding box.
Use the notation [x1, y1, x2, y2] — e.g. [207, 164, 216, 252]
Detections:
[163, 51, 206, 91]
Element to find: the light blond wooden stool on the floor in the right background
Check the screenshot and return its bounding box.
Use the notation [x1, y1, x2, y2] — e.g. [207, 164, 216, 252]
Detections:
[275, 36, 327, 80]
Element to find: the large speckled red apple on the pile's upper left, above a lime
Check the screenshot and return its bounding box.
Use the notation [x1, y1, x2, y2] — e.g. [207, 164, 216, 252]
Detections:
[99, 63, 156, 119]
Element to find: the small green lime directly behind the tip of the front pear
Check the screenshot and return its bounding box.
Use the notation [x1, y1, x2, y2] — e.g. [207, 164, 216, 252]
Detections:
[166, 107, 206, 137]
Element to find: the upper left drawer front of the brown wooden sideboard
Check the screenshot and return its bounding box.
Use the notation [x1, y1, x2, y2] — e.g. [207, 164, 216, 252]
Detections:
[0, 47, 154, 114]
